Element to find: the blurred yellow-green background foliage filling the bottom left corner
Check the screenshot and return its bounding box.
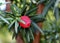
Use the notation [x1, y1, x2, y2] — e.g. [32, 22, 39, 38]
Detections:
[0, 26, 16, 43]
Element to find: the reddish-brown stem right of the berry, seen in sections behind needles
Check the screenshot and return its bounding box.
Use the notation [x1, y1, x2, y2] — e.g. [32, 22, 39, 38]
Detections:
[33, 4, 44, 43]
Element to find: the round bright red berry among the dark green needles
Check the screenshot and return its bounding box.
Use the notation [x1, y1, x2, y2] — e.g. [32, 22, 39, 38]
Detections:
[19, 16, 31, 28]
